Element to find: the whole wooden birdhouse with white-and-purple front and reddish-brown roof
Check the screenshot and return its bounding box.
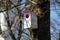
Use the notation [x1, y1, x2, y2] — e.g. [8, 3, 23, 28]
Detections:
[23, 4, 38, 29]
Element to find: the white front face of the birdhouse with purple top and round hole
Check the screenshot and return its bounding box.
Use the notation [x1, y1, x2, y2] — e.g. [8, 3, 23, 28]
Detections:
[24, 12, 31, 28]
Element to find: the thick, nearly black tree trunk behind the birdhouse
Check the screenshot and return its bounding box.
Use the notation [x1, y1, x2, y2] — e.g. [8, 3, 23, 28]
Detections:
[33, 0, 50, 40]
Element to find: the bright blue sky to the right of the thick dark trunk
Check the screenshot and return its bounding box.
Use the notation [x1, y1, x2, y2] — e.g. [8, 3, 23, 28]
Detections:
[50, 0, 60, 40]
